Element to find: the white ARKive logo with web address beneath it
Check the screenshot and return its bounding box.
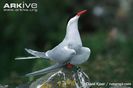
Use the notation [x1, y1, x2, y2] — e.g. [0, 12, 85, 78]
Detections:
[3, 2, 38, 12]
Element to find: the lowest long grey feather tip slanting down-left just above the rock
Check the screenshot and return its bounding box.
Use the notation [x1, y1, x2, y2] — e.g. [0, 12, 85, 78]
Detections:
[26, 64, 64, 77]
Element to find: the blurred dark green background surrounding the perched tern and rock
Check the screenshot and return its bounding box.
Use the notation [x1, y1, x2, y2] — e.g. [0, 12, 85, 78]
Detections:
[0, 0, 133, 85]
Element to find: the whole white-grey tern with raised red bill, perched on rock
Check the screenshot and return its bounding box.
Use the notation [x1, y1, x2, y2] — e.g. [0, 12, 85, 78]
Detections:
[16, 10, 90, 76]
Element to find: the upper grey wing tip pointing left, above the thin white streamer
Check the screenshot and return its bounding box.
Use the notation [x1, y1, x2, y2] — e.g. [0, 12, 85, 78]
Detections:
[25, 49, 48, 58]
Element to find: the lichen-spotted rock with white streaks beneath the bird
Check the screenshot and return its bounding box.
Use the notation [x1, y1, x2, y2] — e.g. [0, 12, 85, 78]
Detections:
[29, 66, 90, 88]
